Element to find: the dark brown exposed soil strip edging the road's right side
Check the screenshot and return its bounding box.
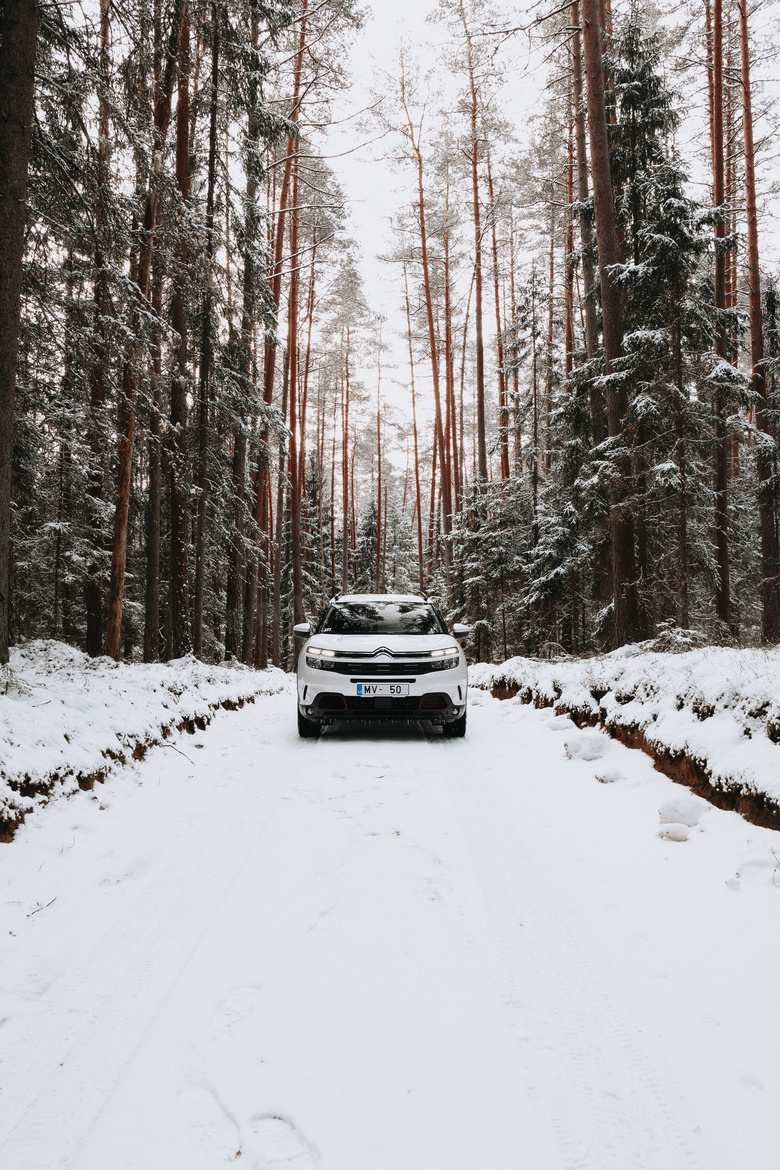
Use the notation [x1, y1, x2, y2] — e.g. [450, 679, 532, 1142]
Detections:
[485, 682, 780, 830]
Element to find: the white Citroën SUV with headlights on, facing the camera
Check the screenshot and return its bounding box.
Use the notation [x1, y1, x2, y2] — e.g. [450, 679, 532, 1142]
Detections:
[294, 593, 470, 738]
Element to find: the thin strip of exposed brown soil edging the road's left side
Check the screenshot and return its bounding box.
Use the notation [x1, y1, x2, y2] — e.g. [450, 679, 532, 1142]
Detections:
[0, 691, 263, 845]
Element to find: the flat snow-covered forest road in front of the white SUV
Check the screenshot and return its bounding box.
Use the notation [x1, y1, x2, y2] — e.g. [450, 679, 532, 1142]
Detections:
[0, 693, 780, 1170]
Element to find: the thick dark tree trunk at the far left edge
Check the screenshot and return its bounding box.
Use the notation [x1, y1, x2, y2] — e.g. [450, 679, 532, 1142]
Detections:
[0, 0, 39, 665]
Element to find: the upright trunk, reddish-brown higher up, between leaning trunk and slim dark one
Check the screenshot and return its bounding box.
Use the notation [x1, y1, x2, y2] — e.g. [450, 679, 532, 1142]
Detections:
[168, 0, 192, 658]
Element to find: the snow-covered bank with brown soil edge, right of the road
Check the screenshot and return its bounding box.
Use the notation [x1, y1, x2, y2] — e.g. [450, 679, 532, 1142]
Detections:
[469, 646, 780, 828]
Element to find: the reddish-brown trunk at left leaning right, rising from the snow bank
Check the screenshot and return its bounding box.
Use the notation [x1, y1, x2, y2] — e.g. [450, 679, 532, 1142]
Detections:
[105, 0, 185, 659]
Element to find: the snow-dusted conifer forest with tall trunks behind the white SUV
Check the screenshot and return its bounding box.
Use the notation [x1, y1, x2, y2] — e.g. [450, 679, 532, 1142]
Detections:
[0, 0, 780, 669]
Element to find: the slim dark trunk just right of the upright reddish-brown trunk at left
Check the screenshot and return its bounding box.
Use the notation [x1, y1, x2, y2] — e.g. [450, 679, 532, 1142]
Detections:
[192, 0, 222, 658]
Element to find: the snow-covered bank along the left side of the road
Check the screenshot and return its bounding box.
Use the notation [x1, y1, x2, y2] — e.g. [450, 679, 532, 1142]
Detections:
[0, 641, 287, 840]
